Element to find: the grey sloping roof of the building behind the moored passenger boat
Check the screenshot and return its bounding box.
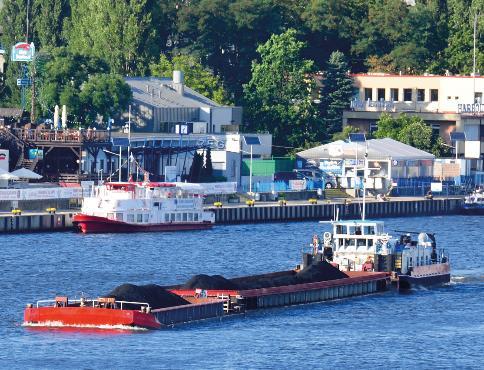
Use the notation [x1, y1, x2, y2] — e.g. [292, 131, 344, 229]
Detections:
[125, 77, 220, 108]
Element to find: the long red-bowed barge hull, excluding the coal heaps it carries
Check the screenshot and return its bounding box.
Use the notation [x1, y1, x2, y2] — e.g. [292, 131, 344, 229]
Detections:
[24, 263, 390, 329]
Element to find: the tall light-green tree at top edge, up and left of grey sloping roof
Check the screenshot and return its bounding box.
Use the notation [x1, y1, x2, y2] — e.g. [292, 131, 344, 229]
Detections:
[67, 0, 160, 75]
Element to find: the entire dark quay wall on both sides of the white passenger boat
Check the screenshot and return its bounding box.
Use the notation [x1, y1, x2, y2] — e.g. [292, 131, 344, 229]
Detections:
[0, 199, 462, 234]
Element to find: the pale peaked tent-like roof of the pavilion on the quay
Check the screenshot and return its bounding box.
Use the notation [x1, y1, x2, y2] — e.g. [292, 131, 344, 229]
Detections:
[297, 138, 435, 160]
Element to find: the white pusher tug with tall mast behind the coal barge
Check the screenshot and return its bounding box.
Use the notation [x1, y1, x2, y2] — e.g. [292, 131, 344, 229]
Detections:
[313, 143, 450, 289]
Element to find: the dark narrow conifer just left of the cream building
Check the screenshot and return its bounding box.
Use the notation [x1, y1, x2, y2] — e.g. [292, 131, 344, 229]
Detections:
[321, 51, 353, 134]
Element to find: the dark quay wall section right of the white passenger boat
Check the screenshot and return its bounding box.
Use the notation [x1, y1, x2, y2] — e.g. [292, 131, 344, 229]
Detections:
[207, 198, 462, 224]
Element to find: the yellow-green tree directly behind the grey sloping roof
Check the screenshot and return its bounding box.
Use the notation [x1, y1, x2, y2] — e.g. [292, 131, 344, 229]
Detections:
[150, 54, 229, 104]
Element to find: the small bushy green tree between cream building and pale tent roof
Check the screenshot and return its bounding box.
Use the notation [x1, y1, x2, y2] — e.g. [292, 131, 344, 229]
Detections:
[375, 113, 449, 157]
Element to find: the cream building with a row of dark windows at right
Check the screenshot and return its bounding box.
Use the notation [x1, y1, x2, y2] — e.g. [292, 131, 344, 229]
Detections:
[343, 73, 484, 175]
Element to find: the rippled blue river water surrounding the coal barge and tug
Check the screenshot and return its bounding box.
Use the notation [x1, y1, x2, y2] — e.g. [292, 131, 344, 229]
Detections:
[0, 216, 484, 369]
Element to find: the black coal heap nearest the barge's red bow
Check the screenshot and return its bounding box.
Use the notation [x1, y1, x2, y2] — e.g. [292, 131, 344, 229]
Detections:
[105, 284, 190, 309]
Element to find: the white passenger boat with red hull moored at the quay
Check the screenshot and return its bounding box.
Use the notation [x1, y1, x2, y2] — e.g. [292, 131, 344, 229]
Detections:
[72, 181, 215, 233]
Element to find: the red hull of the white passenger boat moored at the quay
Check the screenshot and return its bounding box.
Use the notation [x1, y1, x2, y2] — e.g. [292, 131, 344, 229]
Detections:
[72, 213, 213, 234]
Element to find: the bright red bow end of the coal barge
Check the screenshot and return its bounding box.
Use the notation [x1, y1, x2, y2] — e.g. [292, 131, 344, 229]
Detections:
[24, 307, 161, 329]
